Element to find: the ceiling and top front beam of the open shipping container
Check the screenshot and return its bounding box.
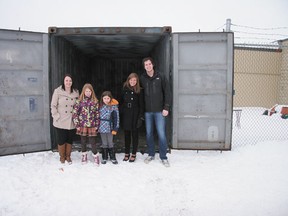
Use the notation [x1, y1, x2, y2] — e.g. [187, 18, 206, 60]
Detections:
[49, 26, 172, 58]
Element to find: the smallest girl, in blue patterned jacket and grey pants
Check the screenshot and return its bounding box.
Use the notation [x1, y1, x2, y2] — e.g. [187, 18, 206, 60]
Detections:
[99, 91, 119, 164]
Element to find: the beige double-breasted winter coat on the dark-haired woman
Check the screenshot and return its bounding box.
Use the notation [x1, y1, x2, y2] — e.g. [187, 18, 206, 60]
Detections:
[51, 86, 79, 130]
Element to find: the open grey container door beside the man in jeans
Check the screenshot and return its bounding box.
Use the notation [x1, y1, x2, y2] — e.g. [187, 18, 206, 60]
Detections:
[172, 32, 233, 150]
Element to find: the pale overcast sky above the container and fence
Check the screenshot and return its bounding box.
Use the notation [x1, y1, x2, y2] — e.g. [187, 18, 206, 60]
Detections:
[0, 0, 288, 43]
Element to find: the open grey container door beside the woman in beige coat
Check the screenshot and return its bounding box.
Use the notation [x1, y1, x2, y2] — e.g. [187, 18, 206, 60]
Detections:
[0, 30, 51, 156]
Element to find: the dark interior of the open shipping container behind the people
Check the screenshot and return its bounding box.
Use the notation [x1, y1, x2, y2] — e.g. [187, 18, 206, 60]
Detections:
[49, 27, 171, 152]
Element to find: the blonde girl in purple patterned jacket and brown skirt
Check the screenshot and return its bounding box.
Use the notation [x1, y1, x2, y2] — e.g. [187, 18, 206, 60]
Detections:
[72, 83, 100, 166]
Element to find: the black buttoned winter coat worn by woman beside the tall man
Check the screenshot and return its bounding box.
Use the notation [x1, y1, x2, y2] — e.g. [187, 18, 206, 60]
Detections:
[120, 87, 144, 131]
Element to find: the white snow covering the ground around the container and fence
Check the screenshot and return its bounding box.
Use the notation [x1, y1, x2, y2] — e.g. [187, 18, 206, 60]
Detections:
[0, 109, 288, 216]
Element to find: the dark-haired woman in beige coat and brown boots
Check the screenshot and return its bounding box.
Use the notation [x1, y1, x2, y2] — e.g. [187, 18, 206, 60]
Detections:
[51, 74, 79, 164]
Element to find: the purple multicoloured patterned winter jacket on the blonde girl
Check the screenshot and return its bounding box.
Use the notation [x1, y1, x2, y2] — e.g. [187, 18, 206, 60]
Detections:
[72, 97, 100, 131]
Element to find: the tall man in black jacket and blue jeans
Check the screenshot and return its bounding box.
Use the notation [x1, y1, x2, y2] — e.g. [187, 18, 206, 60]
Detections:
[140, 57, 171, 167]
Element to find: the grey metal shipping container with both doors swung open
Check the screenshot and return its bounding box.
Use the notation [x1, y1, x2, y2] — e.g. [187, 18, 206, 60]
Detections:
[0, 26, 234, 155]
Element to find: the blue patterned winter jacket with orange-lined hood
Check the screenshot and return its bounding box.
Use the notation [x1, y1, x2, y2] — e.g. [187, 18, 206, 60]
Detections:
[99, 99, 120, 133]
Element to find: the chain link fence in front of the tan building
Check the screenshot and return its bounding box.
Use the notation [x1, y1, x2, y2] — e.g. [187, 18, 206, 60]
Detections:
[232, 40, 288, 147]
